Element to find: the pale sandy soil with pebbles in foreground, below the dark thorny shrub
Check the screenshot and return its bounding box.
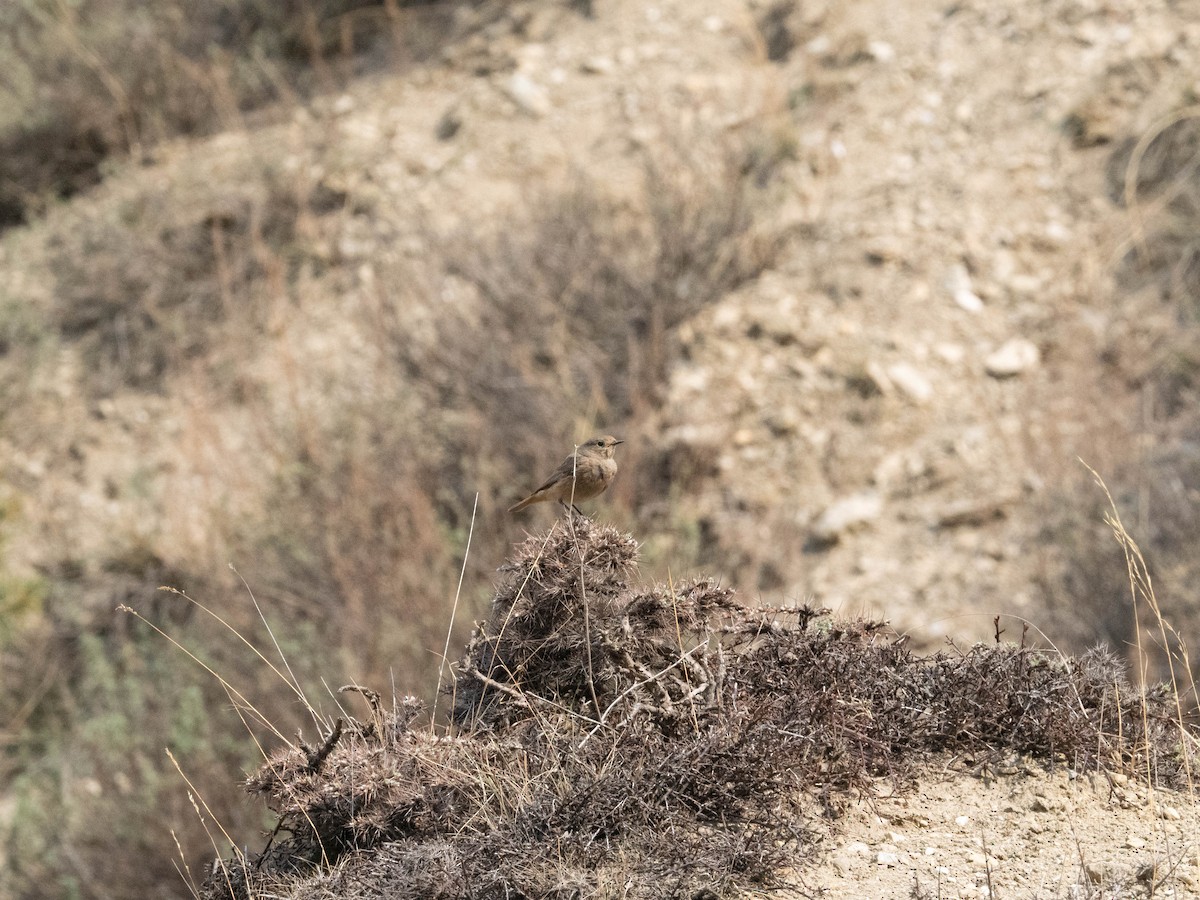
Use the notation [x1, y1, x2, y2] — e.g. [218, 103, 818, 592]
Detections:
[785, 767, 1200, 900]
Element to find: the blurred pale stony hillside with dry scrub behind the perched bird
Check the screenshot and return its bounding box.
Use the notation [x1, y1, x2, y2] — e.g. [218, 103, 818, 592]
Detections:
[0, 0, 1200, 896]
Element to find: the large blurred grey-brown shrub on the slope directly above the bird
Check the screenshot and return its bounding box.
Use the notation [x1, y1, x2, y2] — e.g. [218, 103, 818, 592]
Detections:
[376, 136, 788, 527]
